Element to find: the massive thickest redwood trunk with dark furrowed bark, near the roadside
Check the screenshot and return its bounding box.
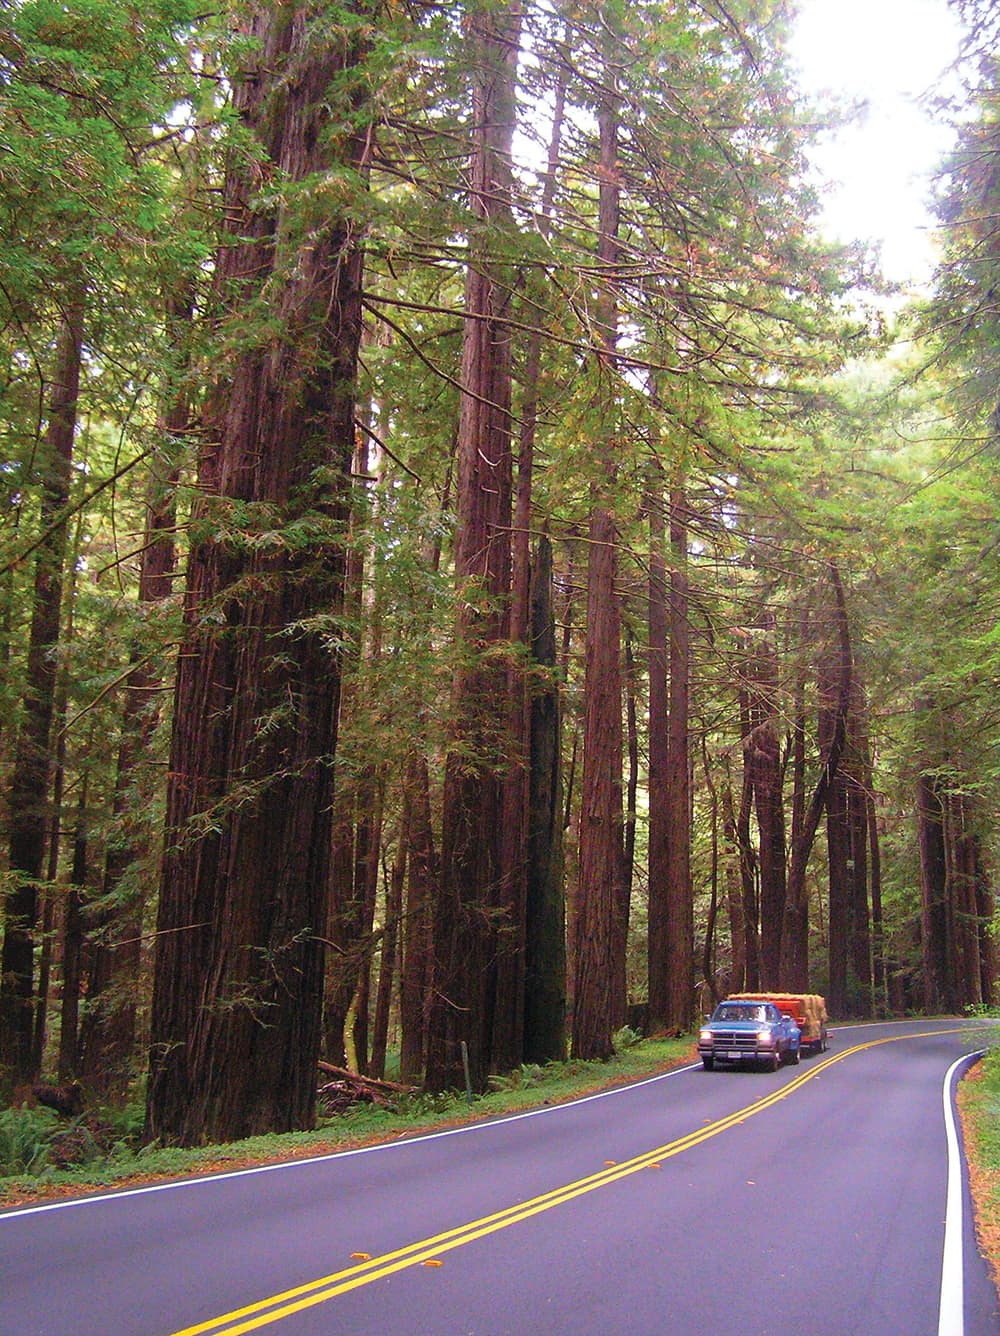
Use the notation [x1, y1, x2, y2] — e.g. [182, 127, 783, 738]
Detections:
[146, 3, 367, 1144]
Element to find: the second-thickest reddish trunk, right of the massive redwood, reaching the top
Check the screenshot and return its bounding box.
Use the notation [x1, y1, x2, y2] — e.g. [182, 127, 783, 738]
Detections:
[426, 3, 523, 1090]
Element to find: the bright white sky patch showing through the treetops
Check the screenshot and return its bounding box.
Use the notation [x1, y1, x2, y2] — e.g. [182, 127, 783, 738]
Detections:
[792, 0, 960, 287]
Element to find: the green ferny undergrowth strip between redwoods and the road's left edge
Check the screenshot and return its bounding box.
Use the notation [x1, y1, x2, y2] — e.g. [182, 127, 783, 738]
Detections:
[0, 1034, 692, 1208]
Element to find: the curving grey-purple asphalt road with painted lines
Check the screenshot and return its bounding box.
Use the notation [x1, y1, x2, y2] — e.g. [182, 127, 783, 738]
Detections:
[0, 1021, 1000, 1336]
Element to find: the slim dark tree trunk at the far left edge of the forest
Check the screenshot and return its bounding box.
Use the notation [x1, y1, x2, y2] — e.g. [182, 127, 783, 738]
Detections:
[0, 297, 83, 1083]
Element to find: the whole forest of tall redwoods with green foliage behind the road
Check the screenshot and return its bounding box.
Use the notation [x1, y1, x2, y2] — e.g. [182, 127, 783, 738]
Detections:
[0, 0, 1000, 1146]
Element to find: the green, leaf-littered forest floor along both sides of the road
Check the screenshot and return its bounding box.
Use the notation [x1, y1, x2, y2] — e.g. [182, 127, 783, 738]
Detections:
[0, 1020, 1000, 1288]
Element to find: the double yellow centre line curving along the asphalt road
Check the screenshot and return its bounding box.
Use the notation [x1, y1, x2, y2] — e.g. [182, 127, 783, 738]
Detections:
[174, 1026, 968, 1336]
